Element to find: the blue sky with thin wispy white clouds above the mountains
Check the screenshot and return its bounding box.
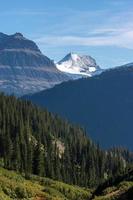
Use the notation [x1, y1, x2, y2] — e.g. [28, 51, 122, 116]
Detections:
[0, 0, 133, 68]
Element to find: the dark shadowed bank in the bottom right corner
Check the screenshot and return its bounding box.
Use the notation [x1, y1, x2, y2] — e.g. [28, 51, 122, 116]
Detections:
[91, 169, 133, 200]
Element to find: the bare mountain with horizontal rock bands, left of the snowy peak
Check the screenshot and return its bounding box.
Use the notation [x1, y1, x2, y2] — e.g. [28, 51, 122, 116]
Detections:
[0, 33, 70, 95]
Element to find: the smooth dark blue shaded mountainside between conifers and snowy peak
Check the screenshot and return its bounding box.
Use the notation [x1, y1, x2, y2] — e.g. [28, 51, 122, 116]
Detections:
[23, 64, 133, 149]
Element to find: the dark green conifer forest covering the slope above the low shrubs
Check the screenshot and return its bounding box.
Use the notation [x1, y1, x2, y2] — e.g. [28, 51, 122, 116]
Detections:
[0, 94, 132, 186]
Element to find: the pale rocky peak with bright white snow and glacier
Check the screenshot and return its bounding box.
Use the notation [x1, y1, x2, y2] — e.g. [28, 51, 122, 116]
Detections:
[56, 53, 102, 77]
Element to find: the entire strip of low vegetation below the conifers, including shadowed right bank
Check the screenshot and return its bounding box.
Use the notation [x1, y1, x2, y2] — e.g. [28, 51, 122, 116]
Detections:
[0, 167, 133, 200]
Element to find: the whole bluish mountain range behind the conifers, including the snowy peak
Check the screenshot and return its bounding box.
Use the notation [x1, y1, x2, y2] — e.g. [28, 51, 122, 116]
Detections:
[0, 33, 133, 148]
